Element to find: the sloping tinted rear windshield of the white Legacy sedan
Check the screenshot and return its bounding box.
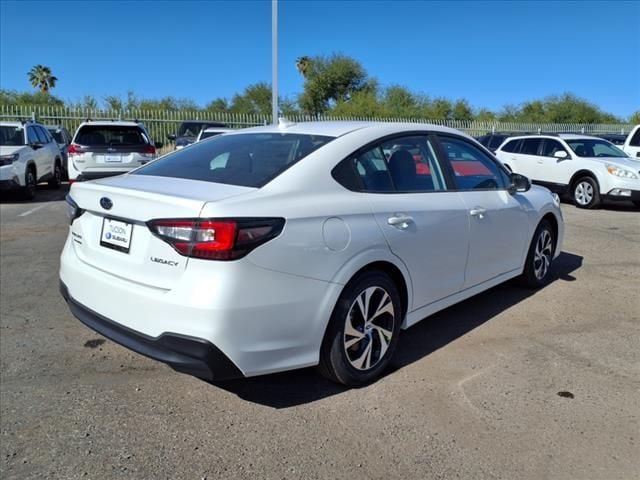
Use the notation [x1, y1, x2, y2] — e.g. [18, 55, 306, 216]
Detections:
[134, 133, 333, 187]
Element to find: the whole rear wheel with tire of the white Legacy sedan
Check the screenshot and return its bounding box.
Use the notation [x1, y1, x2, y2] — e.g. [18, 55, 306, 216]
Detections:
[318, 271, 403, 387]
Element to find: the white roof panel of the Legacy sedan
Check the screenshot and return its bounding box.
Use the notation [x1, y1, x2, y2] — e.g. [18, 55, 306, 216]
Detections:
[232, 121, 471, 138]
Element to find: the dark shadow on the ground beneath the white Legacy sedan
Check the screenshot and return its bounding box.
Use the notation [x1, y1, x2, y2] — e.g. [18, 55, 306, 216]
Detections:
[214, 252, 582, 409]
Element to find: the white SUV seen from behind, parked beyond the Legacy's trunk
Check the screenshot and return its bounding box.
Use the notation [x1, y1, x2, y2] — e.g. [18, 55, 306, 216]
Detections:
[67, 120, 156, 182]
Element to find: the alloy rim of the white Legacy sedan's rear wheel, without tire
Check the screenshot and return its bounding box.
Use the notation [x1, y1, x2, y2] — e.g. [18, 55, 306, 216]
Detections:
[343, 286, 396, 370]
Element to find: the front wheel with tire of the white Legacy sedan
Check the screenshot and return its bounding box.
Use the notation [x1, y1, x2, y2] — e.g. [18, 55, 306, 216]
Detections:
[520, 219, 556, 288]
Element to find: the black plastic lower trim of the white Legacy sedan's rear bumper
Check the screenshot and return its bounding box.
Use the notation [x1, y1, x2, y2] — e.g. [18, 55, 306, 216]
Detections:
[60, 281, 243, 380]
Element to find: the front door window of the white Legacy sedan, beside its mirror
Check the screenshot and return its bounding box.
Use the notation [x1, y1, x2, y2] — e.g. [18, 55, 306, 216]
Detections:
[439, 136, 508, 190]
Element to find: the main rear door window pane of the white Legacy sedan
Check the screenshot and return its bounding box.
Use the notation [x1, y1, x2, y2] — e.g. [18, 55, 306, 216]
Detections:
[381, 135, 446, 192]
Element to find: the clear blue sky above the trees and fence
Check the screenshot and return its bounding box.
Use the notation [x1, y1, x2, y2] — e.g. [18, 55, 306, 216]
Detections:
[0, 0, 640, 117]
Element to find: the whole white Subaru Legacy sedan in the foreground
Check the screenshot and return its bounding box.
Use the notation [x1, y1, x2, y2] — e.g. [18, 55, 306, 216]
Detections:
[60, 122, 564, 386]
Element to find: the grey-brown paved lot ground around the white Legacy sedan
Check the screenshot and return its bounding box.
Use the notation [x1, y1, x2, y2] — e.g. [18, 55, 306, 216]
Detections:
[0, 185, 640, 480]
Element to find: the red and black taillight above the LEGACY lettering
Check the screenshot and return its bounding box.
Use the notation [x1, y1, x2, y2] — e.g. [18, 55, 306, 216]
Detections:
[147, 218, 284, 260]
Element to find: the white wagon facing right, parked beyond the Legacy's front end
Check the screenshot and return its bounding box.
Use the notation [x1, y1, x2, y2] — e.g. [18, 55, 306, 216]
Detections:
[496, 134, 640, 208]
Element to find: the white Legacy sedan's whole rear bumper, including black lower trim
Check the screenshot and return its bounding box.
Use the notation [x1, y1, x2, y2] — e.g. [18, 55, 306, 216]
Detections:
[60, 234, 343, 379]
